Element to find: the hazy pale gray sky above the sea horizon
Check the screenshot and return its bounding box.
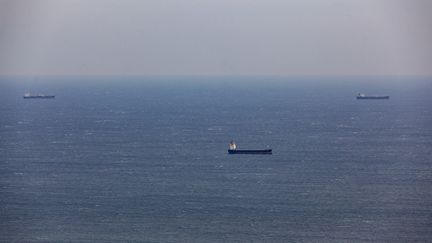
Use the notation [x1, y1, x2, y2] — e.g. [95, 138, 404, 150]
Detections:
[0, 0, 432, 75]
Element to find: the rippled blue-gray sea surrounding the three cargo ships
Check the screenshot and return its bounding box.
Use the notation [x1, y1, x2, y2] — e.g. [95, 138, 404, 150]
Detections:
[0, 77, 432, 242]
